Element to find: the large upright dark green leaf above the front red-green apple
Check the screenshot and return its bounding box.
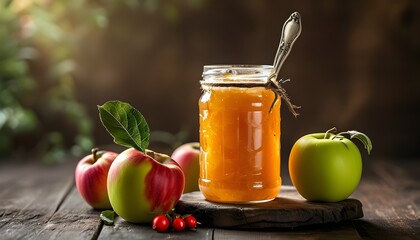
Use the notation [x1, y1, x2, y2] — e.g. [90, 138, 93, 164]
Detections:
[98, 101, 150, 152]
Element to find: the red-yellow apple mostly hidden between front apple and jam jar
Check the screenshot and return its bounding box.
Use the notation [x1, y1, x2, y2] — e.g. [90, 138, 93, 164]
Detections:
[171, 142, 200, 193]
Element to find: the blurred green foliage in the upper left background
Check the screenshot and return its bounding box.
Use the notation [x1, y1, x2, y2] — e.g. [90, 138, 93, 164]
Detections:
[0, 0, 107, 162]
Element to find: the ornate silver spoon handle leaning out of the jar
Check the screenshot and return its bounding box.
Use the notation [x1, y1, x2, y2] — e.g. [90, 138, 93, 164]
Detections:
[273, 12, 302, 78]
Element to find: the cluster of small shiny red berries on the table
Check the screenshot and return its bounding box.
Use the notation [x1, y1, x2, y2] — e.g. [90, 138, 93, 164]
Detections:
[152, 214, 197, 232]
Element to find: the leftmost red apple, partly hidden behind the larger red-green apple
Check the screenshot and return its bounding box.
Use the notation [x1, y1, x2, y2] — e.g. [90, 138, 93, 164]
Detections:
[74, 148, 118, 209]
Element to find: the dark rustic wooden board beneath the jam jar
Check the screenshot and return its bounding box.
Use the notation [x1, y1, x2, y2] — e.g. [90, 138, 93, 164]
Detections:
[176, 186, 363, 229]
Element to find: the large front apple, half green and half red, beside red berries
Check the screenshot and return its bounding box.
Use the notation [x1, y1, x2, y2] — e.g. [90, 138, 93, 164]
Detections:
[107, 148, 185, 223]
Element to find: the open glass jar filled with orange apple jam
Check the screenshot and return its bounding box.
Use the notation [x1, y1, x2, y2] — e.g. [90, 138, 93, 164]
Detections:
[199, 65, 281, 203]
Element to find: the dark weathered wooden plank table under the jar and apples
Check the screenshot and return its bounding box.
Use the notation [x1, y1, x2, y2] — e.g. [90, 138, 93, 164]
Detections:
[0, 159, 420, 239]
